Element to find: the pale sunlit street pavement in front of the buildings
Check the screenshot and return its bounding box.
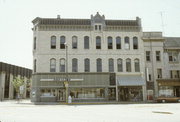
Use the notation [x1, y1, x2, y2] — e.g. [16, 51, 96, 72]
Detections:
[0, 100, 180, 122]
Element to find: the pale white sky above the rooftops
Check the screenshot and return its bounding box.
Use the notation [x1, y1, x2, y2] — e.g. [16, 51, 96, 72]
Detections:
[0, 0, 180, 69]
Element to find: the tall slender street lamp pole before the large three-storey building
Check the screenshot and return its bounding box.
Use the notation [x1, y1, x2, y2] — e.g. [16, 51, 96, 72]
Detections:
[64, 42, 69, 103]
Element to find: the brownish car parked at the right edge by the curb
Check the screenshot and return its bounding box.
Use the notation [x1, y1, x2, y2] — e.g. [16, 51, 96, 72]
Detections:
[156, 97, 180, 103]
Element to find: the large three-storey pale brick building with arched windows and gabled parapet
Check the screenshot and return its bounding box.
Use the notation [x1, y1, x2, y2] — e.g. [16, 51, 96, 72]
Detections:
[31, 13, 147, 102]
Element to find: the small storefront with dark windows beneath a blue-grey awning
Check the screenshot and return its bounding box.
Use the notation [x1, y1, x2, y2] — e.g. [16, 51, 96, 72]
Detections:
[117, 75, 146, 102]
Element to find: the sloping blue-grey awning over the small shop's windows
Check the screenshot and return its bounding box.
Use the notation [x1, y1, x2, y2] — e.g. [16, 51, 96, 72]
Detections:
[117, 75, 146, 86]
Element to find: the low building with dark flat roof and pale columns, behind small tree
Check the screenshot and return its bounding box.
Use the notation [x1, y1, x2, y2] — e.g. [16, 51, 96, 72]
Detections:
[0, 62, 32, 100]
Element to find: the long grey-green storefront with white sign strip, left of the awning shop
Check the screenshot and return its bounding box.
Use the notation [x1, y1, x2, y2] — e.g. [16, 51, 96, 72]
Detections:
[31, 73, 116, 102]
